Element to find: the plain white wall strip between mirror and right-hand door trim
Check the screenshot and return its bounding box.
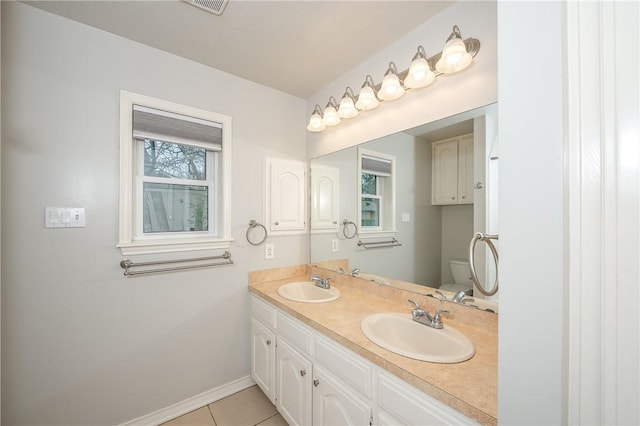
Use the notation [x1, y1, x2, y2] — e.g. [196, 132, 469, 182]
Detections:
[498, 2, 568, 425]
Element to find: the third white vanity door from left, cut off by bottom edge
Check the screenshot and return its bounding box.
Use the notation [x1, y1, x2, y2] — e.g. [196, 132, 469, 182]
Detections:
[313, 364, 372, 426]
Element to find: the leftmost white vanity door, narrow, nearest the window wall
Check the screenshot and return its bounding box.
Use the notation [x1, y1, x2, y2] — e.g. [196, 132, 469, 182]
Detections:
[251, 318, 276, 402]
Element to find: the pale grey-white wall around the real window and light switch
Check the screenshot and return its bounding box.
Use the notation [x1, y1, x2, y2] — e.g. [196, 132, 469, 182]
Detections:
[2, 2, 306, 425]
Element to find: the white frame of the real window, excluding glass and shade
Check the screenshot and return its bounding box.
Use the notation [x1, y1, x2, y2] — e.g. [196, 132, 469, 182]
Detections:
[117, 90, 233, 255]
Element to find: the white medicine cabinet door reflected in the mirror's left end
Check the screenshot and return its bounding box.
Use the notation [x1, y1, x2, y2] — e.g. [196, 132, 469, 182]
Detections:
[311, 165, 340, 230]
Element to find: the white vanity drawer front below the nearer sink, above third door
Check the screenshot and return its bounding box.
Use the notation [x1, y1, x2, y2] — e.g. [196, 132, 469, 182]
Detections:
[314, 334, 373, 399]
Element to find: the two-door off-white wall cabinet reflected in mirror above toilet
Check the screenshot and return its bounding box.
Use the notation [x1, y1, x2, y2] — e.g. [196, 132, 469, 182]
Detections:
[431, 134, 474, 205]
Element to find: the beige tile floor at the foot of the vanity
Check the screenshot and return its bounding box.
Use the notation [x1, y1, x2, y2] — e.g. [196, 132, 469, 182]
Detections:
[162, 385, 288, 426]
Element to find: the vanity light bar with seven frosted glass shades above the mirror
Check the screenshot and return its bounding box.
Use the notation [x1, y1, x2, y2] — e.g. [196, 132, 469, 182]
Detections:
[307, 25, 480, 132]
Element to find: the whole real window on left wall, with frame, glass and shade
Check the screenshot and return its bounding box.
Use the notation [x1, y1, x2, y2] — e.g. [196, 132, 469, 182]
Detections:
[118, 92, 231, 254]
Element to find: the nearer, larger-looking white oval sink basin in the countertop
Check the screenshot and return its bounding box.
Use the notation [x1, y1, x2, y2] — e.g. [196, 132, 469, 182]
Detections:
[360, 313, 475, 364]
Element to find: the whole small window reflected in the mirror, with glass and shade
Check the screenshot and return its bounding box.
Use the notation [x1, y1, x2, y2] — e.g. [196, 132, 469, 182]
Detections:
[358, 149, 395, 237]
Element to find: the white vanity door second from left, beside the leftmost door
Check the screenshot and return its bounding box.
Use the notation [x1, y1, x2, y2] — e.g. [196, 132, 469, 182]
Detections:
[276, 339, 313, 426]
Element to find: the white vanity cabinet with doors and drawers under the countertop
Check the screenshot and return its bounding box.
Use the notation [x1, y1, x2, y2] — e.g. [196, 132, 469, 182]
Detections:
[251, 295, 477, 426]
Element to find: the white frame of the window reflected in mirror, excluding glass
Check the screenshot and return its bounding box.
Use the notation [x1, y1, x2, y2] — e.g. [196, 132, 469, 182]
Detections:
[357, 148, 397, 238]
